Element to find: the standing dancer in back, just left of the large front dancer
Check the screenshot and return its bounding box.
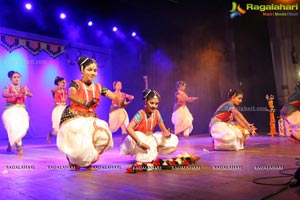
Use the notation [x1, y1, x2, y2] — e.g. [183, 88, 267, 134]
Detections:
[47, 76, 68, 142]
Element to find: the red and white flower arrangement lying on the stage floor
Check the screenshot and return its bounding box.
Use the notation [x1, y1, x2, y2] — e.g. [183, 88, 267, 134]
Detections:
[126, 153, 200, 174]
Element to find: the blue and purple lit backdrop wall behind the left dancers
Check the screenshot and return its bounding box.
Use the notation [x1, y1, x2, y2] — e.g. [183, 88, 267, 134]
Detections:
[0, 28, 112, 139]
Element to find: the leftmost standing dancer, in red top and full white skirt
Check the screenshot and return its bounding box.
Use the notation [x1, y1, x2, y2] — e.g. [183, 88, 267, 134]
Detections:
[2, 71, 32, 155]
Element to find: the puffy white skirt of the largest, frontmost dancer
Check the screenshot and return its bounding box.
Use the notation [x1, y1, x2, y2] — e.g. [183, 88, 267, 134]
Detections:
[56, 117, 113, 167]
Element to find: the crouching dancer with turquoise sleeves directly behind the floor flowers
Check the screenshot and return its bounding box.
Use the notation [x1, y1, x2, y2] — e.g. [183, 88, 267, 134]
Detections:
[120, 89, 178, 162]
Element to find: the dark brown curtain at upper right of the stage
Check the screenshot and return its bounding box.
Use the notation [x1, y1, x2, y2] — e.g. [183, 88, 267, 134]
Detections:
[268, 17, 300, 104]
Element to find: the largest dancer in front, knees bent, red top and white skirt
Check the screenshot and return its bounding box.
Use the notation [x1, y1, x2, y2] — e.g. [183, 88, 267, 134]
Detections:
[57, 56, 119, 170]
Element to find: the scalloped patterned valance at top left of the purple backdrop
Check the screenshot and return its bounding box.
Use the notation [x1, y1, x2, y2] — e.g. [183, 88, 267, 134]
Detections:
[0, 34, 65, 58]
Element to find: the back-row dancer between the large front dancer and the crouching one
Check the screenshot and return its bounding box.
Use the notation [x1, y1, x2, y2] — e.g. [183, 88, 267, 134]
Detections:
[109, 81, 134, 138]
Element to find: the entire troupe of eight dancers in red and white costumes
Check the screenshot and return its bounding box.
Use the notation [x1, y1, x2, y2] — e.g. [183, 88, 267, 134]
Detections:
[2, 56, 300, 169]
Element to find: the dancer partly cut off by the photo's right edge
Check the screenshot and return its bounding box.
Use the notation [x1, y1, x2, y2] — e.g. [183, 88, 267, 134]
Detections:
[280, 81, 300, 144]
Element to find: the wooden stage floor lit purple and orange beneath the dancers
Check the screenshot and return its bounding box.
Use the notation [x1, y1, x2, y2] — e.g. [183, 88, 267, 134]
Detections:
[0, 134, 300, 200]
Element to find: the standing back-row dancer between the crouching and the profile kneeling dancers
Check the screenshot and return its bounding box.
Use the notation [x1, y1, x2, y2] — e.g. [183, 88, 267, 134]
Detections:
[172, 81, 198, 138]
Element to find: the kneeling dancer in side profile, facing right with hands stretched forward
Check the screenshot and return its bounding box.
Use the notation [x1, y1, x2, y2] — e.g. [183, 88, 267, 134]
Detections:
[209, 89, 257, 150]
